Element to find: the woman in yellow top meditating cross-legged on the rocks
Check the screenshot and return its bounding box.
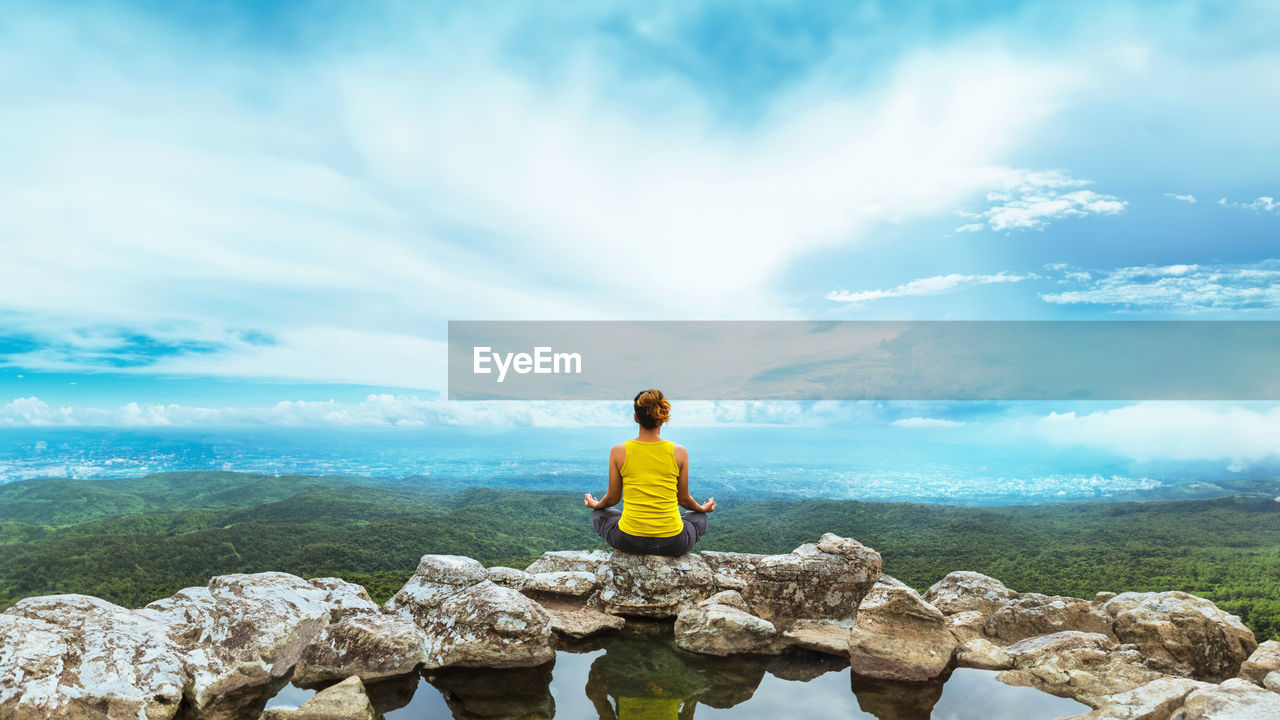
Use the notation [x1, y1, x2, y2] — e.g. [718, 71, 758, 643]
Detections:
[584, 389, 716, 556]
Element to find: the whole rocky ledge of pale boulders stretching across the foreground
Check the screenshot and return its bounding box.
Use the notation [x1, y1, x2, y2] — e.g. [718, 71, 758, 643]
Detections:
[0, 534, 1280, 720]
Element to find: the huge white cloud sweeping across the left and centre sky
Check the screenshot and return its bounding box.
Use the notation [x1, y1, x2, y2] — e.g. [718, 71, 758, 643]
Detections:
[0, 8, 1082, 389]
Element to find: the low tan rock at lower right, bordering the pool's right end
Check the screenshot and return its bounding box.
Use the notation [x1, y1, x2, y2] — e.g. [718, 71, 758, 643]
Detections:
[996, 630, 1164, 707]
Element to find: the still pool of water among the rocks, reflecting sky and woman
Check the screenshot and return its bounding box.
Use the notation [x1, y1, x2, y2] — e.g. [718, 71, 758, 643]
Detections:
[269, 623, 1088, 720]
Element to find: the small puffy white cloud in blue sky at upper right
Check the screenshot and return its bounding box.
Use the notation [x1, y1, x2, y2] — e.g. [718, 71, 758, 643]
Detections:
[956, 170, 1129, 232]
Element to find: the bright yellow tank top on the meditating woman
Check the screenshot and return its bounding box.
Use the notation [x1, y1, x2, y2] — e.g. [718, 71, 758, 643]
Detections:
[618, 439, 685, 538]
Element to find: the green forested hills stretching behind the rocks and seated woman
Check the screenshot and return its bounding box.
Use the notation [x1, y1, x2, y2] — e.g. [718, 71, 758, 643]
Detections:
[0, 473, 1280, 641]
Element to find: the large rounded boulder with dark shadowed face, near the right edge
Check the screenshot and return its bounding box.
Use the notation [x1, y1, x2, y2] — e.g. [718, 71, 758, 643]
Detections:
[1103, 592, 1257, 682]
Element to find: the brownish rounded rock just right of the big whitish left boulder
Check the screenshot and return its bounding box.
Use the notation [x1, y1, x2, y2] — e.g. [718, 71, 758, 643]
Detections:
[293, 614, 426, 687]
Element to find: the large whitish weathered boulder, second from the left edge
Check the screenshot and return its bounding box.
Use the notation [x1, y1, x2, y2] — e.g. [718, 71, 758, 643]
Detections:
[146, 573, 340, 720]
